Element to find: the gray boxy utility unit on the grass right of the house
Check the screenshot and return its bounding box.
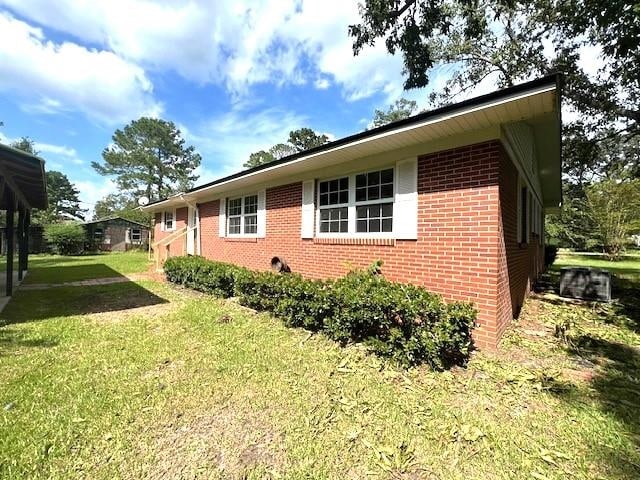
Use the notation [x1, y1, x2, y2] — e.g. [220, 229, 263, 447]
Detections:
[560, 267, 611, 302]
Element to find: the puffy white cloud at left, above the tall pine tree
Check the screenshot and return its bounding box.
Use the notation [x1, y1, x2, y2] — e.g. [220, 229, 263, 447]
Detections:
[0, 12, 161, 123]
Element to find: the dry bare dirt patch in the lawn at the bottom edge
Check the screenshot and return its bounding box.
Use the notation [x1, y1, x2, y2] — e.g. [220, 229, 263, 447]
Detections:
[149, 407, 285, 479]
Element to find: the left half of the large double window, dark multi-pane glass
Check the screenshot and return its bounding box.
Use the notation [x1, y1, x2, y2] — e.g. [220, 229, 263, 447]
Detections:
[320, 177, 349, 233]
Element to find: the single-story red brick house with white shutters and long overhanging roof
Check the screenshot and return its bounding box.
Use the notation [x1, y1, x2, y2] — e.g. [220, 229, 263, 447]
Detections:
[145, 76, 562, 348]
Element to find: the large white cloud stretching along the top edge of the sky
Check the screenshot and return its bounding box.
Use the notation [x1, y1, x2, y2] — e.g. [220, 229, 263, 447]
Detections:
[0, 0, 402, 100]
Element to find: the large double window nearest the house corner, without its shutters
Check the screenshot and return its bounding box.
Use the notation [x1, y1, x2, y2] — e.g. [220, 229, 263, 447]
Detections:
[318, 168, 395, 234]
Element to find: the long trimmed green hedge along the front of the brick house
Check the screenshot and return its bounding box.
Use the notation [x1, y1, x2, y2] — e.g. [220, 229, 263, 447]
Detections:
[164, 256, 476, 369]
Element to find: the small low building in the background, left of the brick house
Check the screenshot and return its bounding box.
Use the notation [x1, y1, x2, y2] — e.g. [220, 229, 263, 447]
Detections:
[83, 217, 150, 252]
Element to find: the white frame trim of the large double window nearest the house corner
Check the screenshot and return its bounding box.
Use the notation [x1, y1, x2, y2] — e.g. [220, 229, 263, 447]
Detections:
[315, 164, 398, 239]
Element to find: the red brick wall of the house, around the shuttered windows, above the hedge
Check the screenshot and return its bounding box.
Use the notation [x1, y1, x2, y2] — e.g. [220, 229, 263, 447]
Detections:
[164, 140, 539, 348]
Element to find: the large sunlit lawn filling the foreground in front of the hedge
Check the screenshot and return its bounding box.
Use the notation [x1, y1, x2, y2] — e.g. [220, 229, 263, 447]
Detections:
[0, 255, 640, 479]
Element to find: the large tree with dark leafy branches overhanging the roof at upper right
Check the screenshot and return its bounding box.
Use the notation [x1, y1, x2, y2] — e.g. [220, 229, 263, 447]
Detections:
[349, 0, 640, 181]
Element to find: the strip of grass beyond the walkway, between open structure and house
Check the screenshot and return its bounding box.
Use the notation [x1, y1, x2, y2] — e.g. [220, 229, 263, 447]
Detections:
[24, 251, 151, 284]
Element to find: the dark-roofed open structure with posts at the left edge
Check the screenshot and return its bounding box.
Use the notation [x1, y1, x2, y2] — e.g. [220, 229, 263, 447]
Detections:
[0, 144, 48, 309]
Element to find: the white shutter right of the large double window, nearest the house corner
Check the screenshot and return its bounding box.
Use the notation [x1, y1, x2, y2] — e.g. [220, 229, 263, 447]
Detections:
[393, 158, 418, 240]
